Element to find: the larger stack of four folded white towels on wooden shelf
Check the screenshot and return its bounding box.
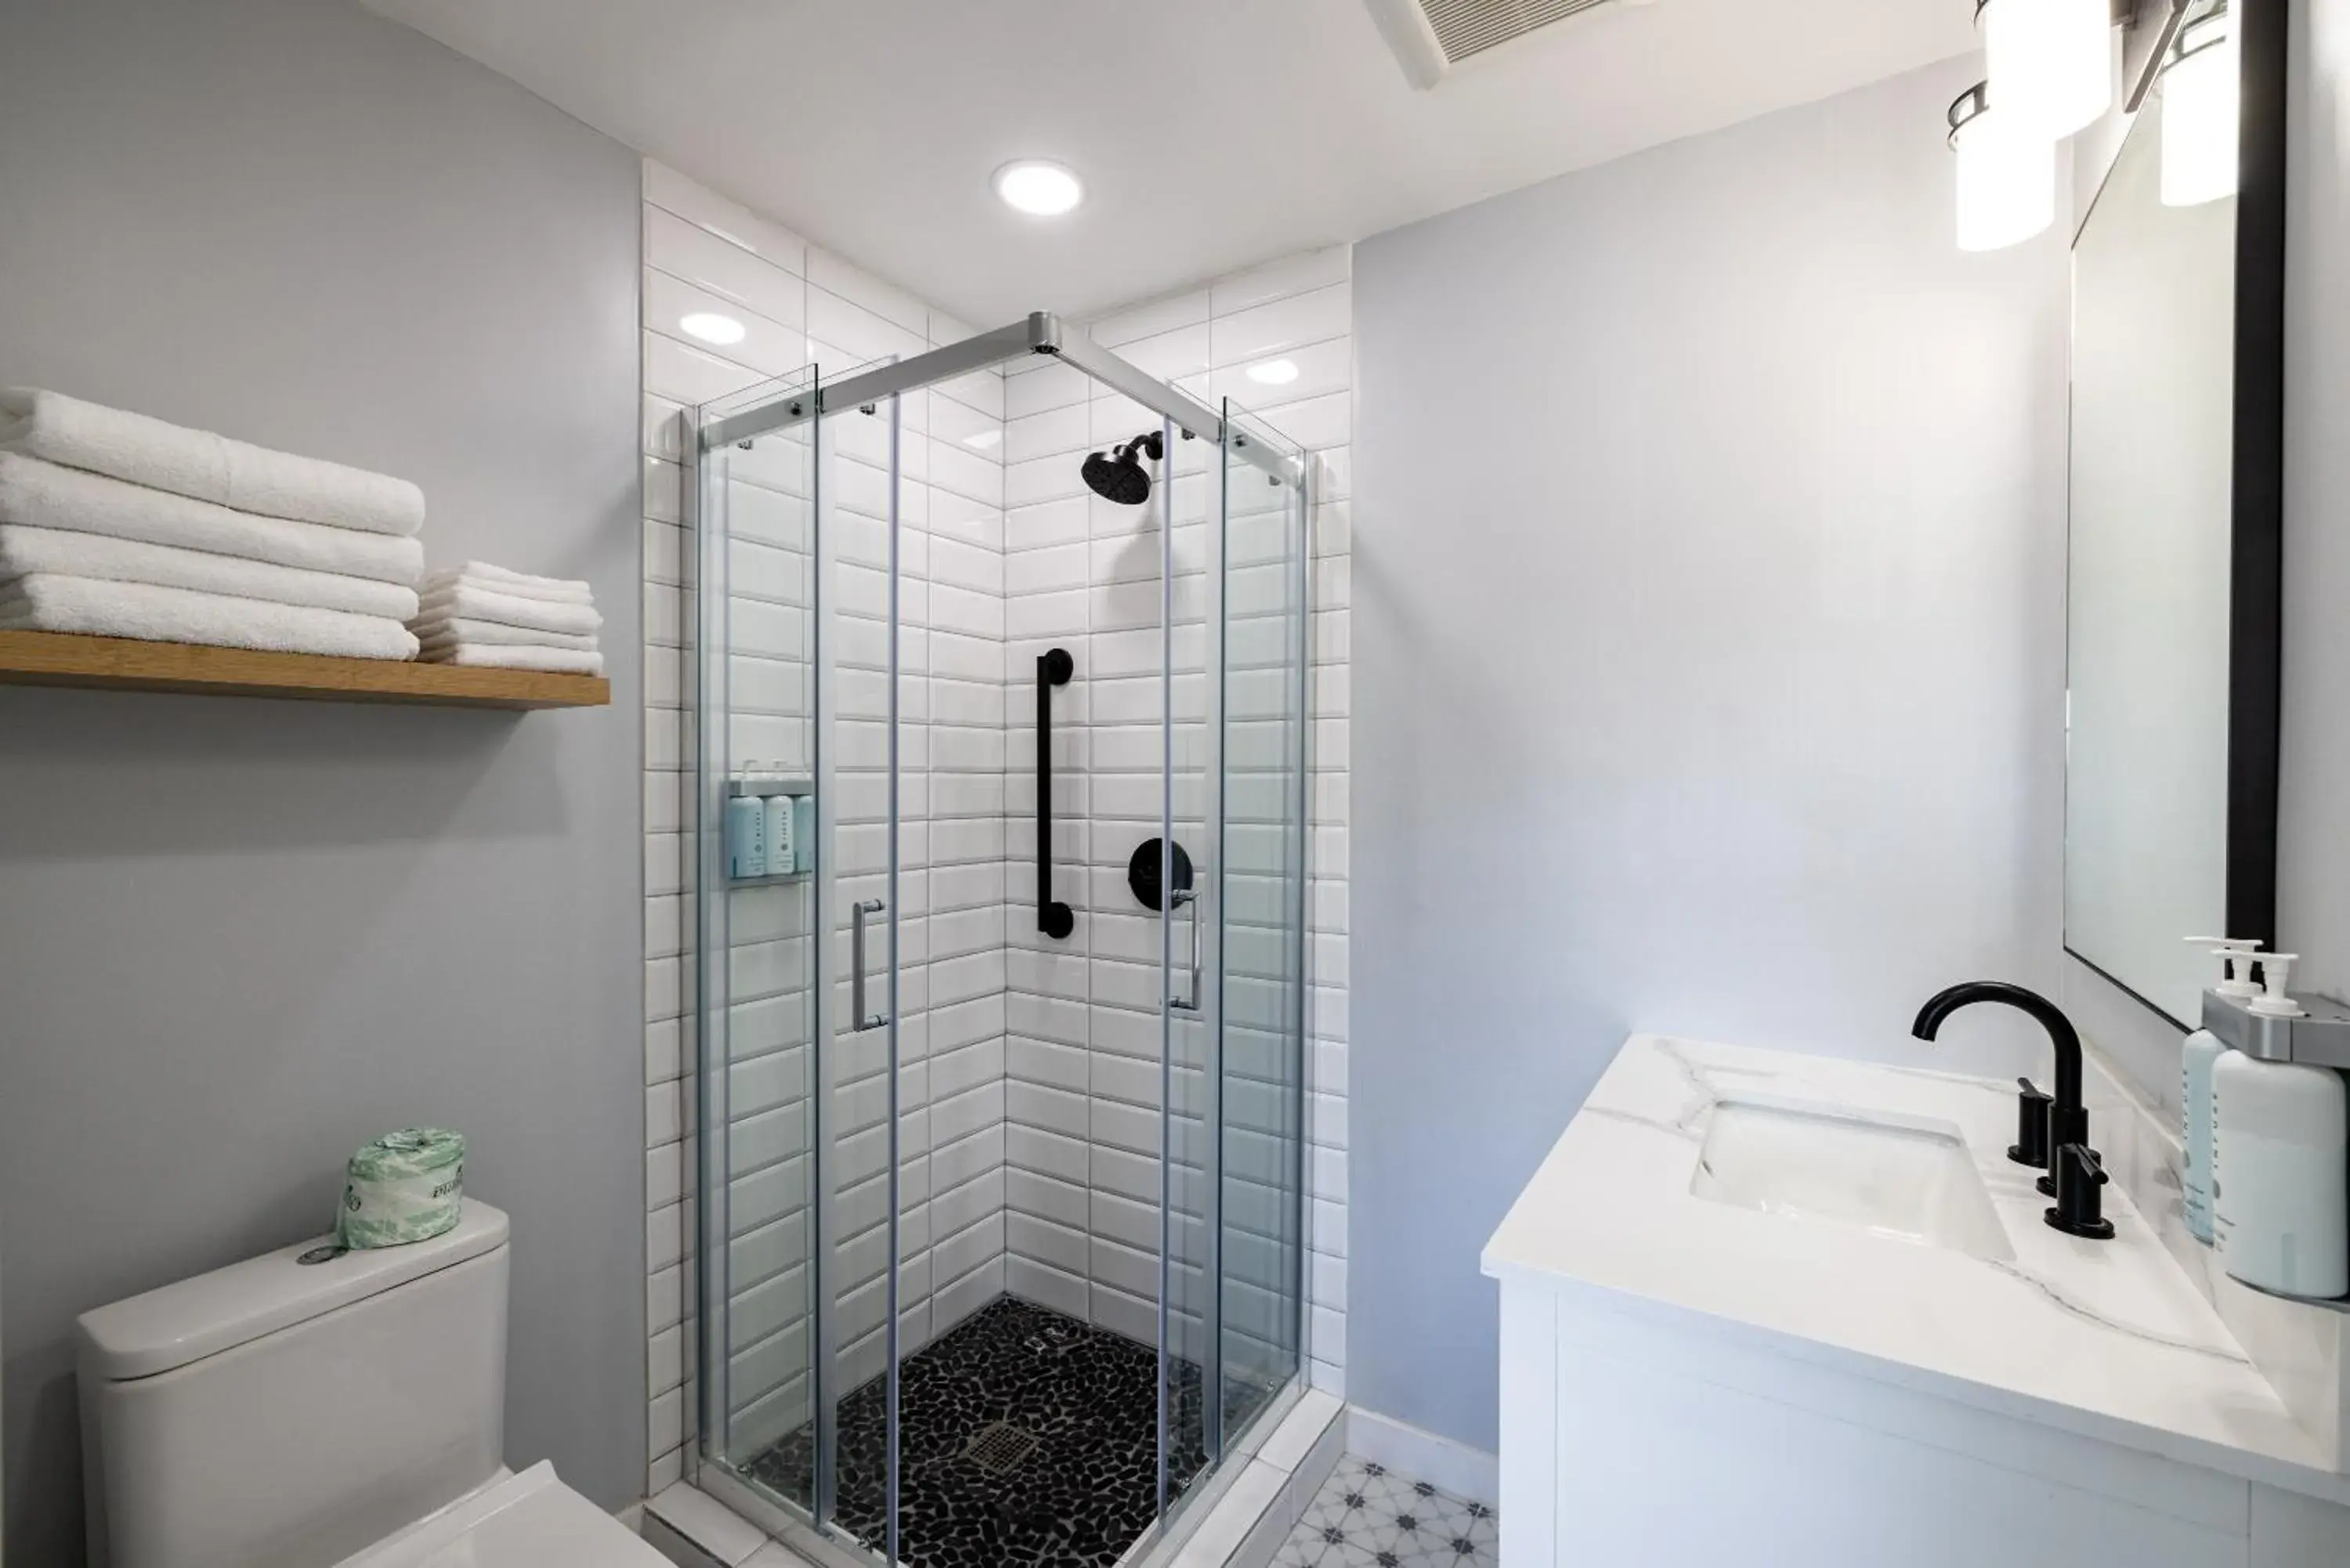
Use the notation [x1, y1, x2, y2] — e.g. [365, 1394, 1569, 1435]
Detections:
[0, 388, 425, 658]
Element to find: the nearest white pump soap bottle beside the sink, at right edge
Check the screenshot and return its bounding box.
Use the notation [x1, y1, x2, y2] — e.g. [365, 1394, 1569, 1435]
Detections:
[2211, 952, 2350, 1298]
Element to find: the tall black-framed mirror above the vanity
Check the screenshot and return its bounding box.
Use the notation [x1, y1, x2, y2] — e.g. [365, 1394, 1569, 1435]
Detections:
[2063, 0, 2287, 1028]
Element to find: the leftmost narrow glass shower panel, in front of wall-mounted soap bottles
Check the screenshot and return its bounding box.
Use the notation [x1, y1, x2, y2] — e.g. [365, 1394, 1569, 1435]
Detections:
[689, 371, 820, 1509]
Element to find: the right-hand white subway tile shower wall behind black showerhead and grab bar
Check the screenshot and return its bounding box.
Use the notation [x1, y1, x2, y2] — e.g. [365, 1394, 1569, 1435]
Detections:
[1003, 247, 1354, 1394]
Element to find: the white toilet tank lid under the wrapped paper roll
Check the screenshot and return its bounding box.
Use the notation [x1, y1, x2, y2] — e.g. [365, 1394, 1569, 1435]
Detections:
[80, 1199, 505, 1382]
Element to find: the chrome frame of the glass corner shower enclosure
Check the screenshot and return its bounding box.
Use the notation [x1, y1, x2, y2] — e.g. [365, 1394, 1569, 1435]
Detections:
[684, 310, 1311, 1568]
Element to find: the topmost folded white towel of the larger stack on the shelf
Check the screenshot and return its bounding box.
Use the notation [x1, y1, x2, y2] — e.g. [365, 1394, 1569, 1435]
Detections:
[0, 385, 425, 536]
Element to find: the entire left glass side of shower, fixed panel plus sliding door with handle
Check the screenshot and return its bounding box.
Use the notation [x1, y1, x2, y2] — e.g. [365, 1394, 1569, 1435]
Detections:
[696, 367, 902, 1554]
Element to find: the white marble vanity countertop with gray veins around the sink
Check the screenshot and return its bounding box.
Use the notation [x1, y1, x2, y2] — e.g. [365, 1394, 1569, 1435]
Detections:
[1483, 1035, 2350, 1502]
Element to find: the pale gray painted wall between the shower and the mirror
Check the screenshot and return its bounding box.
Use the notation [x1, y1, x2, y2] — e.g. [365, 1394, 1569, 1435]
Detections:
[1347, 61, 2066, 1448]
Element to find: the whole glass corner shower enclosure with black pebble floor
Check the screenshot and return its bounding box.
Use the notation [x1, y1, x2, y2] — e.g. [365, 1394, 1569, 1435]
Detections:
[691, 313, 1309, 1568]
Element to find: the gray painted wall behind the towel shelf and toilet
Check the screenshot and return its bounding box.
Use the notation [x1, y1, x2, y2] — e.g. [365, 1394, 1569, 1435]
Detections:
[0, 0, 644, 1563]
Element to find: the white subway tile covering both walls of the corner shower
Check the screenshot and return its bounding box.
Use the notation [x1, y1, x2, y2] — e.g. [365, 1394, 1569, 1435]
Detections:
[644, 162, 1351, 1493]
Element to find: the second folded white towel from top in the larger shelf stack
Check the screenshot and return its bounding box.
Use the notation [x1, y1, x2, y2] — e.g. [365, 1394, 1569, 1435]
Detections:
[0, 451, 425, 587]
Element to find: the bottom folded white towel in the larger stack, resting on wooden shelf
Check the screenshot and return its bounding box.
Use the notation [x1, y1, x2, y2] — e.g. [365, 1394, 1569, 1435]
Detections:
[0, 571, 416, 658]
